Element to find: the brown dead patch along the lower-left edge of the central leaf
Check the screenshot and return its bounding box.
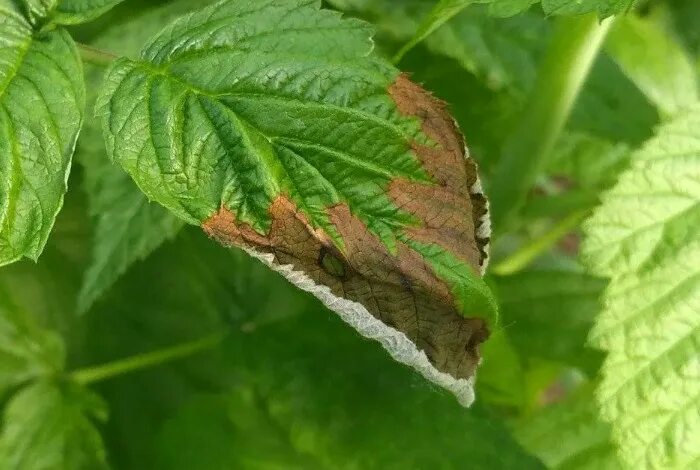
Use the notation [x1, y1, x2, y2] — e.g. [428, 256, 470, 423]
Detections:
[203, 196, 488, 378]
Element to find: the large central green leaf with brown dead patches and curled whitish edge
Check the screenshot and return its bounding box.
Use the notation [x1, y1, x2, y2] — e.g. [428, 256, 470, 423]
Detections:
[98, 0, 497, 403]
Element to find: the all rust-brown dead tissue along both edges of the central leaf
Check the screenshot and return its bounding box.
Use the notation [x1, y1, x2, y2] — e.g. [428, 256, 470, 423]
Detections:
[203, 75, 489, 378]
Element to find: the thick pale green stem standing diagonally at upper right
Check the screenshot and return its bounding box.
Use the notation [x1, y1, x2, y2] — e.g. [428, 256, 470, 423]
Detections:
[489, 14, 612, 232]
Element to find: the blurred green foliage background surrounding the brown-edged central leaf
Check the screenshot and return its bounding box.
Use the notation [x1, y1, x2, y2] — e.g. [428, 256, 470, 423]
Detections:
[0, 0, 700, 470]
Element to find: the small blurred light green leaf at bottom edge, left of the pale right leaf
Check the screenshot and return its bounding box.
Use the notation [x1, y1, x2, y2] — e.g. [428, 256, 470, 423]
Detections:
[515, 385, 623, 470]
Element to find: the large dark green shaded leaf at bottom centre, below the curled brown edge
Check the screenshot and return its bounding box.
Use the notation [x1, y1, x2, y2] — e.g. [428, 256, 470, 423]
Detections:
[156, 311, 541, 469]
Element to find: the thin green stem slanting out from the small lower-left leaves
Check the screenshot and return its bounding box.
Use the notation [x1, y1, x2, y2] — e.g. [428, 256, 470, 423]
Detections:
[70, 333, 227, 385]
